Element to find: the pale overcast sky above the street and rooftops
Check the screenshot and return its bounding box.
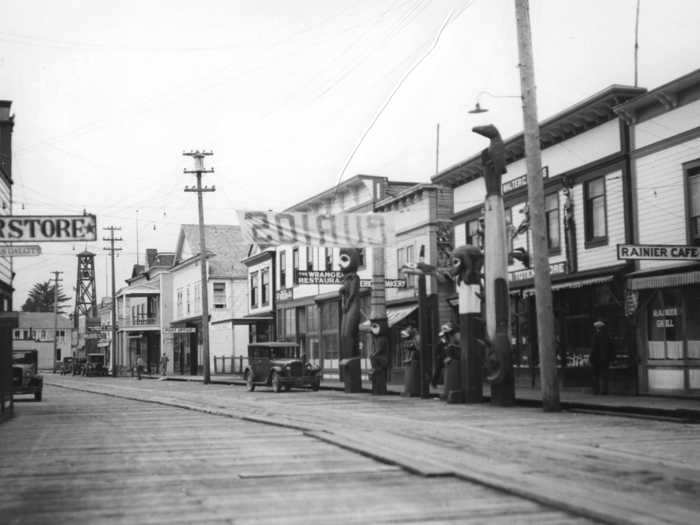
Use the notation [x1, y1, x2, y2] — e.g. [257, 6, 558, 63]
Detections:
[0, 0, 700, 309]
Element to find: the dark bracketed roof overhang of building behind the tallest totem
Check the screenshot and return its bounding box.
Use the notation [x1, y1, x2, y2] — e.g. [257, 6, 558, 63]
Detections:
[431, 84, 646, 188]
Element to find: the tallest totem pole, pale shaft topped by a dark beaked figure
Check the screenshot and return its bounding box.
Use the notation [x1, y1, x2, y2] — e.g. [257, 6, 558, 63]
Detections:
[472, 124, 515, 406]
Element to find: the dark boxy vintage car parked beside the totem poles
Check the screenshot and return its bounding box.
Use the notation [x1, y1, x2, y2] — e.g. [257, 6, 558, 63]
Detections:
[243, 342, 322, 392]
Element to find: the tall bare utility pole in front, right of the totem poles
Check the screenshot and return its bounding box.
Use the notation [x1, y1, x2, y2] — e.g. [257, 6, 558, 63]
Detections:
[515, 0, 560, 412]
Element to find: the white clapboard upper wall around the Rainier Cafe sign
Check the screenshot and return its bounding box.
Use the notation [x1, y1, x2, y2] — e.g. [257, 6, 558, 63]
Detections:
[634, 135, 700, 270]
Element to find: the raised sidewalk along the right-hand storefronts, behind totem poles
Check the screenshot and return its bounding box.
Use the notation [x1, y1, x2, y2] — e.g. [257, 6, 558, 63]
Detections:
[145, 374, 700, 421]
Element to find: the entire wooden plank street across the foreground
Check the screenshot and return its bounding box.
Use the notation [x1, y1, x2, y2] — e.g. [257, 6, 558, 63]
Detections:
[0, 375, 700, 523]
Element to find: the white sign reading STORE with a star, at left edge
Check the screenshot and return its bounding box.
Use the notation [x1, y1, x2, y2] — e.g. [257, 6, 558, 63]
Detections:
[0, 215, 97, 242]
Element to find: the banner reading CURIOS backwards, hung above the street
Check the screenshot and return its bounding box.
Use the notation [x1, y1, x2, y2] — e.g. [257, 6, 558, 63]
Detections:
[236, 210, 394, 248]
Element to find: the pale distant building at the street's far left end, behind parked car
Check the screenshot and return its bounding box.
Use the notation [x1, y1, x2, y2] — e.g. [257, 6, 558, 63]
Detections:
[12, 312, 73, 370]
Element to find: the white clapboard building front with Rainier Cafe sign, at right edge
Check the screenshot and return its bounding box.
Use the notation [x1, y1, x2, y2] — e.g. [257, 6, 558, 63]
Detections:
[616, 70, 700, 395]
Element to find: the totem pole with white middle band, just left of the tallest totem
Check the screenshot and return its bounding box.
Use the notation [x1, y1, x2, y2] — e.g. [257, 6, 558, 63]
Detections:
[452, 244, 484, 403]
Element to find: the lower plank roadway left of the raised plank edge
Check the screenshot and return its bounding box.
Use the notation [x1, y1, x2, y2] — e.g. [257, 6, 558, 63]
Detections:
[0, 379, 587, 524]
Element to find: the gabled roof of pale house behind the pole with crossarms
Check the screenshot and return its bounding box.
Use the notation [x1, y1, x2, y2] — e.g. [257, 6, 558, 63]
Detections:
[175, 224, 250, 278]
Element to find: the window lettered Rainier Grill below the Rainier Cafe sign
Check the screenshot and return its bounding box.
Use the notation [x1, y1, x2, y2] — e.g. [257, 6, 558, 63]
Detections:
[647, 289, 684, 361]
